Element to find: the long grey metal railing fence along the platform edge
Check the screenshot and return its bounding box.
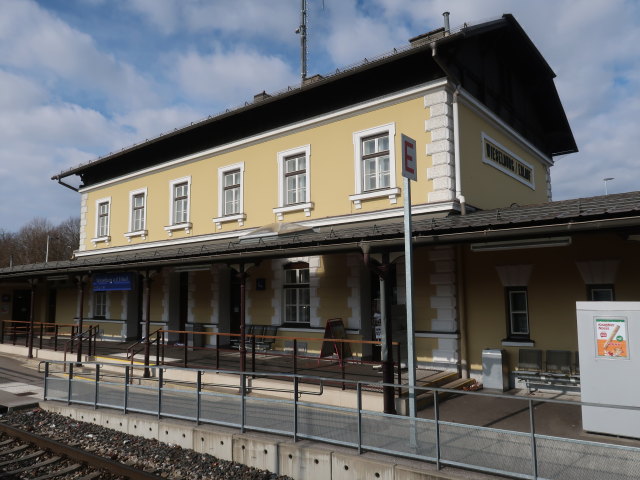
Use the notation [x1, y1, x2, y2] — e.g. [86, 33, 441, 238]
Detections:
[44, 362, 640, 480]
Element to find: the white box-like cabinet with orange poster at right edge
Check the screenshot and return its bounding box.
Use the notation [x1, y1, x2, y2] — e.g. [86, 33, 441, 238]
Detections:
[576, 302, 640, 438]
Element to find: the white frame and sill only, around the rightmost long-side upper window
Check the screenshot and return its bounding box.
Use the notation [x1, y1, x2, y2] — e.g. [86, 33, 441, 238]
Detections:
[349, 122, 400, 209]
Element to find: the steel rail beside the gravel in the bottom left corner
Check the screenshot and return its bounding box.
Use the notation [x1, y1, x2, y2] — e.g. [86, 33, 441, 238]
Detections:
[0, 422, 163, 480]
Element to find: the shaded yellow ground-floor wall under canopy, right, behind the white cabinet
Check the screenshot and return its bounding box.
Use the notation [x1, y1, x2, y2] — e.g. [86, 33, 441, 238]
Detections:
[464, 235, 640, 371]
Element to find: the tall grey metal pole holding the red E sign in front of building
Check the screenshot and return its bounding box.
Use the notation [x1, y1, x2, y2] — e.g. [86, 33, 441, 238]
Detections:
[398, 177, 417, 417]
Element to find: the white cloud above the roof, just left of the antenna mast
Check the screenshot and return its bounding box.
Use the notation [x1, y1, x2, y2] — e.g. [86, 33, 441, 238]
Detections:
[175, 48, 298, 106]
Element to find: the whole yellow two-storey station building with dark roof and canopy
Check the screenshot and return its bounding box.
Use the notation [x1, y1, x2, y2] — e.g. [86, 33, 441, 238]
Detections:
[0, 15, 640, 380]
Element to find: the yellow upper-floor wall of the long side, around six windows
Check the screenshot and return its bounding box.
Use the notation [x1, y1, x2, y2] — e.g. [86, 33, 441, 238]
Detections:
[80, 95, 431, 250]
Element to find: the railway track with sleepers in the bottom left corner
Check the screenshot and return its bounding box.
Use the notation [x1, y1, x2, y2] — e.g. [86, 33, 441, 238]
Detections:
[0, 422, 162, 480]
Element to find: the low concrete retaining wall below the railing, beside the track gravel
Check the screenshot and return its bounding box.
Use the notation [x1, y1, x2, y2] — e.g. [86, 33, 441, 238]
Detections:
[40, 402, 468, 480]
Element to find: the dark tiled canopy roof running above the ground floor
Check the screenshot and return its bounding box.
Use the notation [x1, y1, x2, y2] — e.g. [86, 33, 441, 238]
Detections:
[0, 192, 640, 279]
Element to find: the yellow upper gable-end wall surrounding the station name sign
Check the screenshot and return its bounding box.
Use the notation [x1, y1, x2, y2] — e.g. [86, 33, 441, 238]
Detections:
[459, 103, 548, 209]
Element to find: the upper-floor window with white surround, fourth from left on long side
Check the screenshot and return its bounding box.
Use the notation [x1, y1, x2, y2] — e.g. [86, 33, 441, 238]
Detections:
[213, 162, 246, 229]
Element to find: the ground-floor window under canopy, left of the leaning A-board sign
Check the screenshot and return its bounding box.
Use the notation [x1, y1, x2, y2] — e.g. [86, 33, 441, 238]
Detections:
[283, 262, 311, 326]
